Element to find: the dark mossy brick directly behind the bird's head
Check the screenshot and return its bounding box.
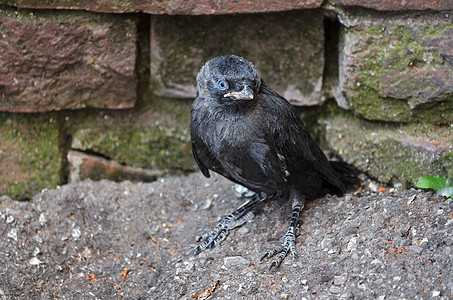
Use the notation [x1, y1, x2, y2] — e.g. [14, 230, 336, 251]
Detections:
[151, 11, 324, 105]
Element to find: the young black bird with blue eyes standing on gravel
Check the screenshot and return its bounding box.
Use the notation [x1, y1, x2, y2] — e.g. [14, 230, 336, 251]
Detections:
[190, 56, 345, 270]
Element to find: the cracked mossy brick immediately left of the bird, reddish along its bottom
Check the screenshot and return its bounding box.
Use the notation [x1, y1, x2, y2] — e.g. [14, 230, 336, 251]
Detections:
[65, 99, 194, 180]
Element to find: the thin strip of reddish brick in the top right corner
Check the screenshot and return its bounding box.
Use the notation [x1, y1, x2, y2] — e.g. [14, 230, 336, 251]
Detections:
[334, 0, 453, 11]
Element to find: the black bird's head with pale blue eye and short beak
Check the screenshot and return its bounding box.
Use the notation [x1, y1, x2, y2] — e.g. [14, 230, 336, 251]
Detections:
[197, 55, 261, 103]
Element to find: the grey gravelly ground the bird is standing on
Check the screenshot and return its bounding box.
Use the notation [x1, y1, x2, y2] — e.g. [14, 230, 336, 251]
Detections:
[0, 173, 453, 299]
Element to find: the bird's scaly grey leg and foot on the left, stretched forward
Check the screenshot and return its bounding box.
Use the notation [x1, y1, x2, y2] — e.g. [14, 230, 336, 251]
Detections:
[193, 193, 268, 255]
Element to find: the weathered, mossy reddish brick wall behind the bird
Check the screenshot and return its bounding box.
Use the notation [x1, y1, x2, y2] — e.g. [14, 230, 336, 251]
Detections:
[0, 0, 453, 199]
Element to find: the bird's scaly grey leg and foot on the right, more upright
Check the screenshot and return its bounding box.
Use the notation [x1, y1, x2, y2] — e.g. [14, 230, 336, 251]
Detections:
[261, 193, 305, 271]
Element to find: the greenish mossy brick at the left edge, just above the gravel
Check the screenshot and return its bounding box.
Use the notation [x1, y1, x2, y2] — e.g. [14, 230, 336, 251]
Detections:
[0, 113, 61, 200]
